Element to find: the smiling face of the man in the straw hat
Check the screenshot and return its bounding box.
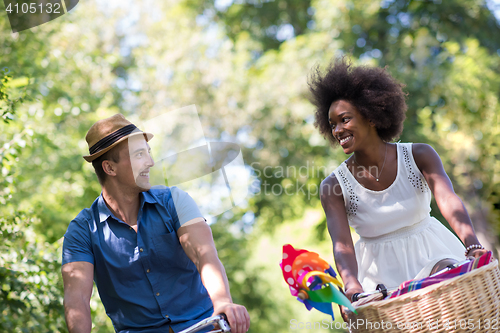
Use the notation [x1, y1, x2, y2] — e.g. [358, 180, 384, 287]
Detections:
[120, 135, 155, 191]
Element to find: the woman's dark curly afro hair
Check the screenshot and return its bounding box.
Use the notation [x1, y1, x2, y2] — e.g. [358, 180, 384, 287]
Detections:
[309, 57, 407, 145]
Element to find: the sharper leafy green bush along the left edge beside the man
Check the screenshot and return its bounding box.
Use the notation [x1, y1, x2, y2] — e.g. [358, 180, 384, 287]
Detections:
[0, 72, 66, 332]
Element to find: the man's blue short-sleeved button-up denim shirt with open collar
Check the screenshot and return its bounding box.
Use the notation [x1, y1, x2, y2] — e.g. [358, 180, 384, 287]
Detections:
[62, 187, 213, 333]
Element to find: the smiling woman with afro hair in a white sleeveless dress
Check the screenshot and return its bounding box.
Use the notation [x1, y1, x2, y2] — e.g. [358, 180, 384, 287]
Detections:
[310, 59, 486, 308]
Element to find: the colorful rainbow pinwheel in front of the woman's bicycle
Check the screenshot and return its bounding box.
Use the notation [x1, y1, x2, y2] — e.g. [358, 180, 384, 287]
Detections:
[280, 244, 356, 319]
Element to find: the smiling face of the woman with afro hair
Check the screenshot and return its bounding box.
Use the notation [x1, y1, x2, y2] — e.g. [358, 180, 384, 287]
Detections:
[328, 100, 377, 154]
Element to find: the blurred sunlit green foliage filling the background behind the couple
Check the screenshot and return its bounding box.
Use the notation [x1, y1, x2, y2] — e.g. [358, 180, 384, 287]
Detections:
[0, 0, 500, 332]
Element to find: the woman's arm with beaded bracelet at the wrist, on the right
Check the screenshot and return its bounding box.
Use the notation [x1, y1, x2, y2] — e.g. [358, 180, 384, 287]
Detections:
[412, 143, 485, 257]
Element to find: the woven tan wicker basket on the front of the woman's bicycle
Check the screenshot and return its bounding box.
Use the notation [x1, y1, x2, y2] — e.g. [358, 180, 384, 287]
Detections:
[348, 260, 500, 333]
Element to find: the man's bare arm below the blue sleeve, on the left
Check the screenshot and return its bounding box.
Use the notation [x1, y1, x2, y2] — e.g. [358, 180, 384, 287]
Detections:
[61, 261, 94, 333]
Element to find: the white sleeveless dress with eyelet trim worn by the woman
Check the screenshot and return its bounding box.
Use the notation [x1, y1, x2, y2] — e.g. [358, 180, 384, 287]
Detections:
[333, 143, 465, 291]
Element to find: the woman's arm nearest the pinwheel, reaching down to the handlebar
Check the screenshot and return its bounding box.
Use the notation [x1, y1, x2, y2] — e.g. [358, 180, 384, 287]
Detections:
[320, 175, 363, 299]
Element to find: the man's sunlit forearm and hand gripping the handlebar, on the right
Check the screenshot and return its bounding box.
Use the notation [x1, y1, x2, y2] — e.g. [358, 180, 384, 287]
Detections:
[177, 221, 250, 333]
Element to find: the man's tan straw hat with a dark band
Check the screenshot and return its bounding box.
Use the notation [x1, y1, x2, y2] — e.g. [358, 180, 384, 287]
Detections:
[83, 113, 153, 162]
